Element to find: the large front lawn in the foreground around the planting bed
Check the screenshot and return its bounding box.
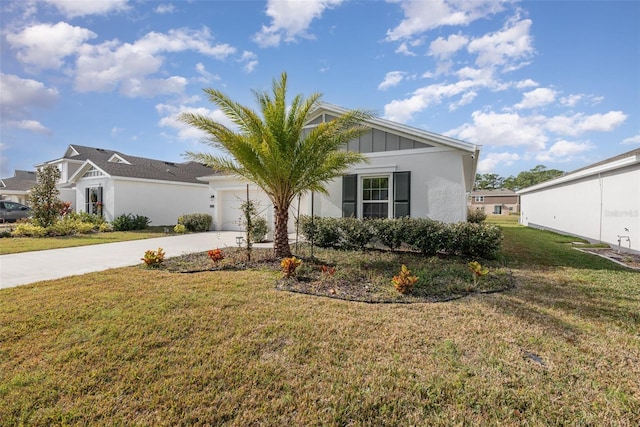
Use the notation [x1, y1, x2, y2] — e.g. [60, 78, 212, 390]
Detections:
[0, 219, 640, 426]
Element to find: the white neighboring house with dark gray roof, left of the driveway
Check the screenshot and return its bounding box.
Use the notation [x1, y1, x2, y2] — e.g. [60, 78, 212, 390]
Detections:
[36, 144, 212, 225]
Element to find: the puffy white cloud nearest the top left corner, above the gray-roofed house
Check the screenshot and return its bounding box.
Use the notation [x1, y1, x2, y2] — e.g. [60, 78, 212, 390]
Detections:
[7, 22, 97, 69]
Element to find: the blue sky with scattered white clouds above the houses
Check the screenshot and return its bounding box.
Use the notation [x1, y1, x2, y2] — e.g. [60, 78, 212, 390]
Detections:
[0, 0, 640, 177]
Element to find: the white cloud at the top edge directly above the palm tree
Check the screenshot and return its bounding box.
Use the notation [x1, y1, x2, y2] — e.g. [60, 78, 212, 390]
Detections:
[253, 0, 343, 47]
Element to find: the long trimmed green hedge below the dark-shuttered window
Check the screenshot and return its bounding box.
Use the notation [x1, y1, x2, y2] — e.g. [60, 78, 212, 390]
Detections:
[300, 216, 502, 259]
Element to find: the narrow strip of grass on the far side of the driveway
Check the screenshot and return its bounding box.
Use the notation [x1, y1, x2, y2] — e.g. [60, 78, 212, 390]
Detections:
[0, 227, 172, 255]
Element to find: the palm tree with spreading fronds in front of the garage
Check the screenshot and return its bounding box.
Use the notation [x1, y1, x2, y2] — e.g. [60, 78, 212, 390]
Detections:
[180, 73, 371, 258]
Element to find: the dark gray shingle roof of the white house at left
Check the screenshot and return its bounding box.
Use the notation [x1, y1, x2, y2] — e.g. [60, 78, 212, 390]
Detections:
[64, 144, 215, 184]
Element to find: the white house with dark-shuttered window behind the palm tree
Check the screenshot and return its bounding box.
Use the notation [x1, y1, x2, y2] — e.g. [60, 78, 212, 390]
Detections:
[200, 103, 479, 230]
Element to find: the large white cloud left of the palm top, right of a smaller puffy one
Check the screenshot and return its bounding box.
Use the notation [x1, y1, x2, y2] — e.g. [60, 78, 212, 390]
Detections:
[75, 29, 235, 96]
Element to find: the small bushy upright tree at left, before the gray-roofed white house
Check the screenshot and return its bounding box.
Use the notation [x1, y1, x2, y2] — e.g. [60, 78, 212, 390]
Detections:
[29, 165, 62, 227]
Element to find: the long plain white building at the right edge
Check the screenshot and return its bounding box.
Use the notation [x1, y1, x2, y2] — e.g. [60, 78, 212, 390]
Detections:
[518, 149, 640, 252]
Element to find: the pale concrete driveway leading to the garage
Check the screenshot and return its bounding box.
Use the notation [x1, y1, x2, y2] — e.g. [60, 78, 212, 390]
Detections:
[0, 231, 272, 289]
